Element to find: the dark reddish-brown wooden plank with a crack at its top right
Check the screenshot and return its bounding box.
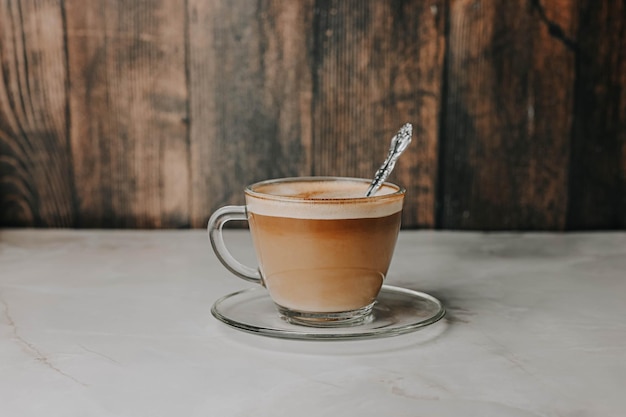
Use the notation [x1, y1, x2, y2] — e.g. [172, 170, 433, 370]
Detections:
[438, 0, 576, 230]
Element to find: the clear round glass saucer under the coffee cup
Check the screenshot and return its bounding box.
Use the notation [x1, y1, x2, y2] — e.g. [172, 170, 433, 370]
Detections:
[211, 285, 445, 340]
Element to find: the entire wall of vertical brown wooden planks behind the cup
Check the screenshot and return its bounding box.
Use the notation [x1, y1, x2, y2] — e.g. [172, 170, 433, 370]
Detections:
[0, 0, 626, 230]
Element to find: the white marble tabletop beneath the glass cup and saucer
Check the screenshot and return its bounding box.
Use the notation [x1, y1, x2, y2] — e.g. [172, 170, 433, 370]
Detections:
[0, 230, 626, 417]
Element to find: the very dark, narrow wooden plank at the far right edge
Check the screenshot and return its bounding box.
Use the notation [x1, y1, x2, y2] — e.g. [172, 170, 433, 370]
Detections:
[567, 0, 626, 229]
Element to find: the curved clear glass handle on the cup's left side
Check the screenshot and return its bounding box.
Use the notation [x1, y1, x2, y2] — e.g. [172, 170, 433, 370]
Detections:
[207, 206, 263, 285]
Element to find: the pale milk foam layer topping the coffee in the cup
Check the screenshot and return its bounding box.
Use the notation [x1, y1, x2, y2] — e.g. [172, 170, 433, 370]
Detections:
[246, 178, 404, 219]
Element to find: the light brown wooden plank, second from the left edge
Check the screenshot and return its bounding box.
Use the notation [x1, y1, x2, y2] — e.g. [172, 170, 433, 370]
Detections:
[65, 0, 190, 228]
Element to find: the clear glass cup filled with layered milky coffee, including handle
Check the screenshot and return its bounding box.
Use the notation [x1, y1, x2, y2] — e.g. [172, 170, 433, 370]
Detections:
[208, 177, 405, 327]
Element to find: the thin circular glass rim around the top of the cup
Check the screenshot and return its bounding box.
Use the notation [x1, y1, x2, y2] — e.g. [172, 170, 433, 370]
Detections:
[244, 176, 406, 204]
